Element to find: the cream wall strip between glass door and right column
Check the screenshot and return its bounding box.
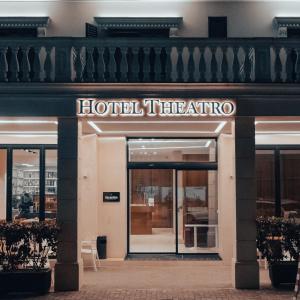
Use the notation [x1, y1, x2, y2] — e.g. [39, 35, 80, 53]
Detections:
[218, 134, 235, 265]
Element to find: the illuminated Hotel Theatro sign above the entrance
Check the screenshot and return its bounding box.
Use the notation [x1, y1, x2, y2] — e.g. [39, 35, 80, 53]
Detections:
[77, 98, 236, 117]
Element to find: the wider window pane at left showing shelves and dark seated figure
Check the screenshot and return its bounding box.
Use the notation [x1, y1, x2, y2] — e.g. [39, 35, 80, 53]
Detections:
[12, 149, 40, 220]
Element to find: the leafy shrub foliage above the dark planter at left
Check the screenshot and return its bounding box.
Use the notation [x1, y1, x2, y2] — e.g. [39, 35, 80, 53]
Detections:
[0, 222, 59, 271]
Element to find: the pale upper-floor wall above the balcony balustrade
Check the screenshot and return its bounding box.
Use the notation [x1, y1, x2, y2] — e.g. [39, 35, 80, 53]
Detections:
[0, 0, 300, 37]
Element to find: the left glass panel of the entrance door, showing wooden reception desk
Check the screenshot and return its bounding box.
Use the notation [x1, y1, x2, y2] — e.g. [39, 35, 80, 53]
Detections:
[129, 169, 176, 253]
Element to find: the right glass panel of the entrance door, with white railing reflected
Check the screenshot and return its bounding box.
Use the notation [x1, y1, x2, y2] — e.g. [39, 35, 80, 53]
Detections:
[177, 170, 218, 253]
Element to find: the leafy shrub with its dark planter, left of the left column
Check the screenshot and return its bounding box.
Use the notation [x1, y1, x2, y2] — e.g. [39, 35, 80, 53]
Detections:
[0, 222, 58, 294]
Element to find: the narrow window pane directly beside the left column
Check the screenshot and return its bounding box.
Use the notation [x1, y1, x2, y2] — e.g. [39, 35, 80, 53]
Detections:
[45, 149, 57, 219]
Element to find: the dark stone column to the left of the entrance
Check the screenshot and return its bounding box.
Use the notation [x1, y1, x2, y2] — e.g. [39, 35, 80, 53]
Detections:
[55, 117, 81, 291]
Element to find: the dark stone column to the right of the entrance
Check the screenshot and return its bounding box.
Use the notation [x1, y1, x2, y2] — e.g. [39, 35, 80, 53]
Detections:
[233, 117, 259, 289]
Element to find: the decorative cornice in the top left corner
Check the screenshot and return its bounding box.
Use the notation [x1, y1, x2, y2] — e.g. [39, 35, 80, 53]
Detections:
[0, 17, 50, 28]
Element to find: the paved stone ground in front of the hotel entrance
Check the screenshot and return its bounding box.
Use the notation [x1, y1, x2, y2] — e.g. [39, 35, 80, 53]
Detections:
[2, 261, 300, 300]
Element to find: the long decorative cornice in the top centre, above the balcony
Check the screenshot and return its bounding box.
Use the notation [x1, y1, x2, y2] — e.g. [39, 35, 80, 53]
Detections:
[94, 17, 183, 29]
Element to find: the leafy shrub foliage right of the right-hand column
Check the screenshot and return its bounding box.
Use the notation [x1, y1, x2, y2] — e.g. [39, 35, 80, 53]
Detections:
[256, 217, 300, 264]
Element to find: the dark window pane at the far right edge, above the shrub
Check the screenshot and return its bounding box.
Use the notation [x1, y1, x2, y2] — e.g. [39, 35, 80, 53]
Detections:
[280, 150, 300, 222]
